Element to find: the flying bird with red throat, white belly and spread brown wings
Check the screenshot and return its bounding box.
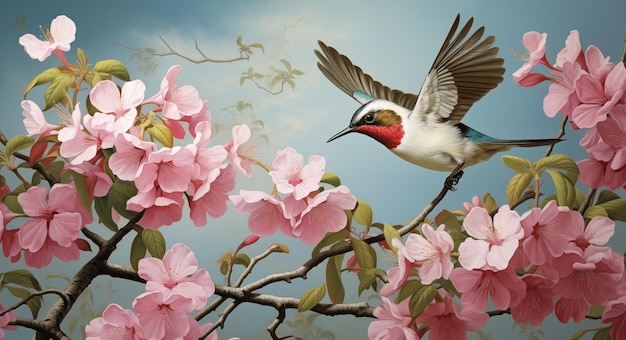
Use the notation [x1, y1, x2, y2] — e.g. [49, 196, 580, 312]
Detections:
[314, 14, 561, 190]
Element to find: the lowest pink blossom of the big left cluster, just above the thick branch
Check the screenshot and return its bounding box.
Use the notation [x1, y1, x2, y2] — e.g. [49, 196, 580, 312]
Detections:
[126, 187, 185, 229]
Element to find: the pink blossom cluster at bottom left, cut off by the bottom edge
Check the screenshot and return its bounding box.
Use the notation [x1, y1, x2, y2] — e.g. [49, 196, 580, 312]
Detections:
[86, 243, 227, 340]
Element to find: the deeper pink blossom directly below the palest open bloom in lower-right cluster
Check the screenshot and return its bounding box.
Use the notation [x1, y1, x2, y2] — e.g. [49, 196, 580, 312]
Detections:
[450, 266, 526, 310]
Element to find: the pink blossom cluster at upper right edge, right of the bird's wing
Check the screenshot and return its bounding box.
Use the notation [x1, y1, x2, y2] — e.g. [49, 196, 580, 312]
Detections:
[513, 30, 626, 189]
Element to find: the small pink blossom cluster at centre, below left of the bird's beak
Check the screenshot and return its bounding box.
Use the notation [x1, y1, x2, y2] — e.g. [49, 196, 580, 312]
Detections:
[230, 147, 356, 244]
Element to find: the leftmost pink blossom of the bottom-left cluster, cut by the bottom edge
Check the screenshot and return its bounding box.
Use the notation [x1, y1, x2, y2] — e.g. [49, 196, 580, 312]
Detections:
[85, 304, 145, 340]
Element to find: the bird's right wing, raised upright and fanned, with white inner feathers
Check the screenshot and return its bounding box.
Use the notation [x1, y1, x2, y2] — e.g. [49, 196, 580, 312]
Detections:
[411, 15, 504, 123]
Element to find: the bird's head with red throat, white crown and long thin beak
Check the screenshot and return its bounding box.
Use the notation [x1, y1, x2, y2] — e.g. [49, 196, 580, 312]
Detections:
[327, 99, 406, 149]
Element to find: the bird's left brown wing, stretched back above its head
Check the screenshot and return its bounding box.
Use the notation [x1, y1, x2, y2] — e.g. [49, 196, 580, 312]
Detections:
[315, 41, 417, 110]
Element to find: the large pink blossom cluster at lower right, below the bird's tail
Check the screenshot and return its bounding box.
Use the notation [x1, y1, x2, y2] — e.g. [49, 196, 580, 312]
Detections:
[369, 201, 626, 339]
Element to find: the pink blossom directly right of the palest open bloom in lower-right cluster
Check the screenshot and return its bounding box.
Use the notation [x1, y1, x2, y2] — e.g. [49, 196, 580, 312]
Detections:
[521, 200, 576, 265]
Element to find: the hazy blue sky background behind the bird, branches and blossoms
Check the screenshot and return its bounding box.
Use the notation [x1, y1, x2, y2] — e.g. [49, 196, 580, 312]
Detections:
[0, 0, 626, 339]
